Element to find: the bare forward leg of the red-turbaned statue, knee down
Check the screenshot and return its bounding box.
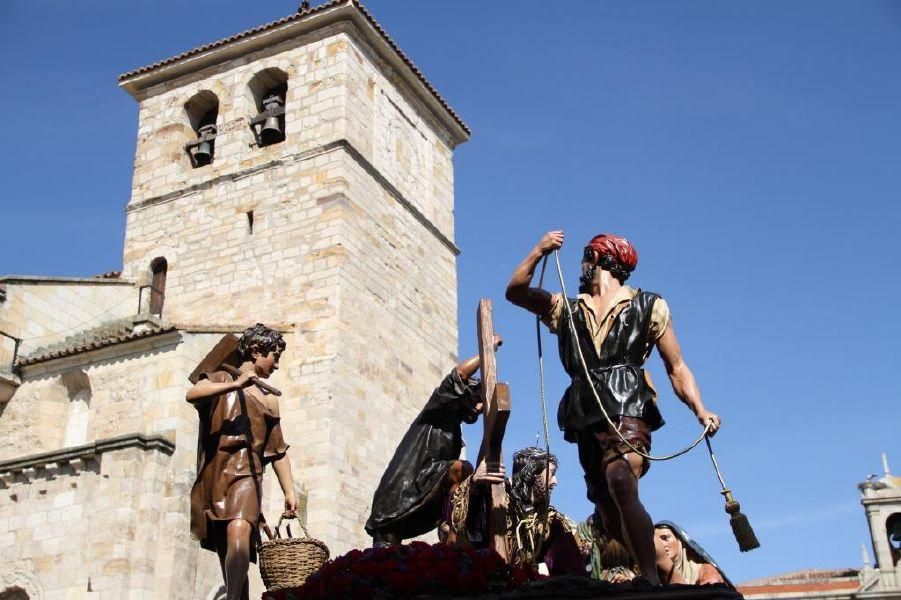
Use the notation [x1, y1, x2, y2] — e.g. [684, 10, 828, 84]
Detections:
[604, 452, 660, 585]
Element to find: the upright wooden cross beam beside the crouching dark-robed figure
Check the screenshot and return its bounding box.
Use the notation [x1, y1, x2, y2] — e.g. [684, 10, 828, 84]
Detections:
[476, 298, 510, 562]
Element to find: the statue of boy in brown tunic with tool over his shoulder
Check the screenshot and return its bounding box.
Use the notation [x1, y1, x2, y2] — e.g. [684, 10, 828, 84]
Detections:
[186, 323, 297, 600]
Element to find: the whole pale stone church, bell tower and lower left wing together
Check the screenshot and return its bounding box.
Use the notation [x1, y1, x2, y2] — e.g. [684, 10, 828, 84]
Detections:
[0, 0, 469, 600]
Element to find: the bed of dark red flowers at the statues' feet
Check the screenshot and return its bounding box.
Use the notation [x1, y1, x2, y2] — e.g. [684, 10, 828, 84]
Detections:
[263, 542, 540, 600]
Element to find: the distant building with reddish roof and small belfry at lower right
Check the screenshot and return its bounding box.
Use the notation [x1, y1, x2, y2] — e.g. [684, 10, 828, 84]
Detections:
[738, 455, 901, 600]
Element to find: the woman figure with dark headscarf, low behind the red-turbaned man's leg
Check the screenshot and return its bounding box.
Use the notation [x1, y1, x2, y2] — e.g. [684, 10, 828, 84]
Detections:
[654, 521, 732, 586]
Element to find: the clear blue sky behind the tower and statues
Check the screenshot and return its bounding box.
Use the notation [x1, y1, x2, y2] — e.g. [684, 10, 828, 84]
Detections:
[0, 0, 901, 581]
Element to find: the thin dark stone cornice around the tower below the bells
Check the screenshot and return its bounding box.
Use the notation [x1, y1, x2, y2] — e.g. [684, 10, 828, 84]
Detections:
[125, 138, 460, 256]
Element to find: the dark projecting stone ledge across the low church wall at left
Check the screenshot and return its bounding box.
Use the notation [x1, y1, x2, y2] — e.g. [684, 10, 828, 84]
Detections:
[0, 433, 175, 487]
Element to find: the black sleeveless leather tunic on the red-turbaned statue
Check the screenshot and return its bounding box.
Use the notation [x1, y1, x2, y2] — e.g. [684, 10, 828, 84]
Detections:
[557, 290, 663, 442]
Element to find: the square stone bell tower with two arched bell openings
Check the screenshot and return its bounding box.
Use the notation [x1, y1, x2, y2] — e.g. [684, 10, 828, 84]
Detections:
[119, 0, 469, 596]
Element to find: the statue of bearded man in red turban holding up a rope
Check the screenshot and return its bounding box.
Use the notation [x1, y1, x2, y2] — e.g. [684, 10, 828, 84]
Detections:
[507, 231, 720, 584]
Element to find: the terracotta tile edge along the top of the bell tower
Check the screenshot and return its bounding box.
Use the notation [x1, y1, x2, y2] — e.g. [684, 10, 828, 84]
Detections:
[119, 0, 472, 134]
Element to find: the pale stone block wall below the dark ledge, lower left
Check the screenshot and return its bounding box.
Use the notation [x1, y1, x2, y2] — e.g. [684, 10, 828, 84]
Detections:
[0, 438, 175, 600]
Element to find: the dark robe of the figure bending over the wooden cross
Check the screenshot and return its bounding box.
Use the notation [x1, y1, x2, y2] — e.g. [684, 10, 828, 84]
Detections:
[366, 368, 478, 539]
